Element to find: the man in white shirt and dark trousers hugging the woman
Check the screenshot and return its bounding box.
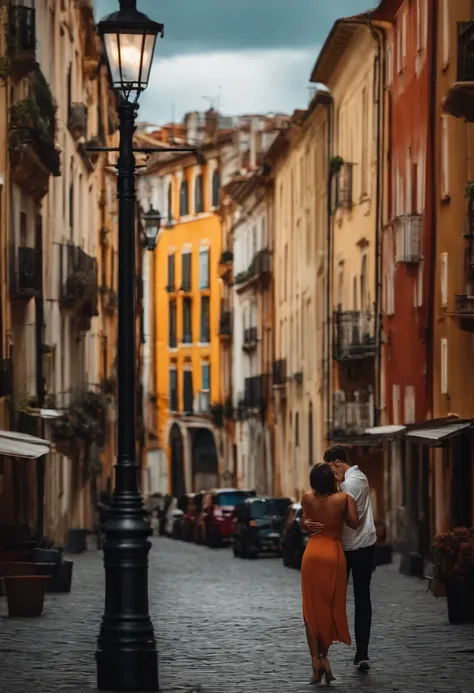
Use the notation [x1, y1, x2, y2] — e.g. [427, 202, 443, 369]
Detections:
[306, 445, 377, 671]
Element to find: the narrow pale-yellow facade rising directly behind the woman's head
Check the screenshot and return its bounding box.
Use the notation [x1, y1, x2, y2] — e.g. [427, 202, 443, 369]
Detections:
[266, 91, 330, 500]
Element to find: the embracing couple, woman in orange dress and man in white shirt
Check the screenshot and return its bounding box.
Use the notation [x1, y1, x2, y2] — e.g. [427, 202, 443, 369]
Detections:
[301, 445, 376, 684]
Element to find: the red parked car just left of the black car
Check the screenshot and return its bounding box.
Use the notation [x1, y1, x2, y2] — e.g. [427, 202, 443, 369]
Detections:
[200, 488, 256, 547]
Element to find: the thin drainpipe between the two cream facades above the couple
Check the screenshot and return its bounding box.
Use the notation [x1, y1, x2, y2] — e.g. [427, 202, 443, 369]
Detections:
[325, 96, 334, 440]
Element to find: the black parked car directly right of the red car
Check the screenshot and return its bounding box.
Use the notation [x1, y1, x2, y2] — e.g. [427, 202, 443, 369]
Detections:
[233, 497, 291, 558]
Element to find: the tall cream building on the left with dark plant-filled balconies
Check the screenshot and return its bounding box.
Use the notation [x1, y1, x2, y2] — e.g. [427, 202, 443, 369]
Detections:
[0, 0, 116, 543]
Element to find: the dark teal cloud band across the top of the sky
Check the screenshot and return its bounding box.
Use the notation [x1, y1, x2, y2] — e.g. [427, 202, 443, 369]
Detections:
[96, 0, 378, 56]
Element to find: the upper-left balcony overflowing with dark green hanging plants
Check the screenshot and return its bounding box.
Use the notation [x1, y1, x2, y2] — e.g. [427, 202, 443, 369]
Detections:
[8, 93, 61, 201]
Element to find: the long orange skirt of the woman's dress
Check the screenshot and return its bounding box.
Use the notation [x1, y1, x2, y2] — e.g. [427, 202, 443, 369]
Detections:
[301, 534, 351, 649]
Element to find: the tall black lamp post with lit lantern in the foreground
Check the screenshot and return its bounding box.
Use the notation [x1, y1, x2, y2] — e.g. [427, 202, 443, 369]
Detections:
[96, 0, 163, 692]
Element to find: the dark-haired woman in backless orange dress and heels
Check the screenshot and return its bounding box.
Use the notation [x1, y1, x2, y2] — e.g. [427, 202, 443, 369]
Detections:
[301, 464, 360, 684]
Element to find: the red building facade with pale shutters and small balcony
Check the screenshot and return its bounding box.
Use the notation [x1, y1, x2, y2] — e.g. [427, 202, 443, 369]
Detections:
[382, 0, 434, 425]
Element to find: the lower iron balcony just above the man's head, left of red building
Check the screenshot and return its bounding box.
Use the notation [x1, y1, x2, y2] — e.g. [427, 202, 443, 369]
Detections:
[332, 390, 374, 440]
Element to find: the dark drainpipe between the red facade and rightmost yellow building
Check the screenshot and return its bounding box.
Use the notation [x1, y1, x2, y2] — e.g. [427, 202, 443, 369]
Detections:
[426, 0, 439, 417]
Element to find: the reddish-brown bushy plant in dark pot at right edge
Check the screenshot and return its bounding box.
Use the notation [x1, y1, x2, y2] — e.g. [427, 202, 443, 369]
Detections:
[432, 527, 474, 623]
